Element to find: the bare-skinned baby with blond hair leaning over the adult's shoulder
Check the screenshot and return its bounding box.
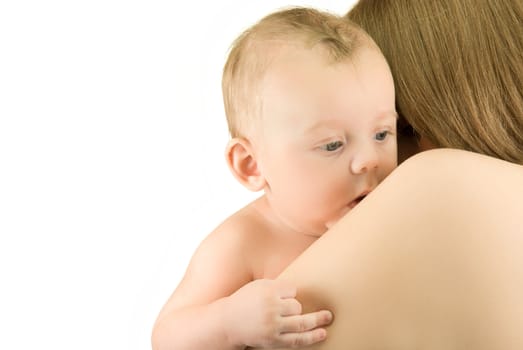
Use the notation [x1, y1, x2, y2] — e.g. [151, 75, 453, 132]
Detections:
[153, 8, 397, 349]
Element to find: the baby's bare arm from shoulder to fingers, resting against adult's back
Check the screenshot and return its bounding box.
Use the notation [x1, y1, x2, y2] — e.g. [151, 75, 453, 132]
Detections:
[152, 229, 332, 350]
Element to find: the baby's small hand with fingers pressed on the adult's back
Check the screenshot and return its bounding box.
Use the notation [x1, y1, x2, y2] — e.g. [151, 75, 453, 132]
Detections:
[225, 280, 332, 348]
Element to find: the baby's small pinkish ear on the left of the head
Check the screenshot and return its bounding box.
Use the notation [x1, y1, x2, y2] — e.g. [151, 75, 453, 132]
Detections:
[225, 137, 266, 192]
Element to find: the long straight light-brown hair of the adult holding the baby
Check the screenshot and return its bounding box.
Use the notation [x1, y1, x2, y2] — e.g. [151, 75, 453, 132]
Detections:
[346, 0, 523, 164]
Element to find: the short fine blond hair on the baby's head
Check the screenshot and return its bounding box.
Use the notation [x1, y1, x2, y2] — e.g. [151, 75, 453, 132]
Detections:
[222, 7, 370, 137]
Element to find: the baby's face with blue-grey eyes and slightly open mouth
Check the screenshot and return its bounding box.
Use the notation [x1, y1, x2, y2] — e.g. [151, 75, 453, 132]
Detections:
[254, 43, 397, 235]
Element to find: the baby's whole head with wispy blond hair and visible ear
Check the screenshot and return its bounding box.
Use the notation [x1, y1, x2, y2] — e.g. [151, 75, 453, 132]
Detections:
[223, 8, 396, 235]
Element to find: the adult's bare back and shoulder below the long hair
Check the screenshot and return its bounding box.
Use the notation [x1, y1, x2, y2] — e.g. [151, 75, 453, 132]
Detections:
[280, 150, 523, 350]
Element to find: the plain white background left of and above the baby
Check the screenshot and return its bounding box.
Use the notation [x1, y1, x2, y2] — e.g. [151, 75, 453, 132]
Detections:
[0, 0, 355, 350]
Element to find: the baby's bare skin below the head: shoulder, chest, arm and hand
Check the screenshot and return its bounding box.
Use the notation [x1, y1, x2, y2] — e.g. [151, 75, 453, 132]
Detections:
[153, 197, 332, 349]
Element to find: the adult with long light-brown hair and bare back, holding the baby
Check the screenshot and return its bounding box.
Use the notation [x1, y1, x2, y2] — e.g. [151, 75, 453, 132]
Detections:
[280, 0, 523, 350]
